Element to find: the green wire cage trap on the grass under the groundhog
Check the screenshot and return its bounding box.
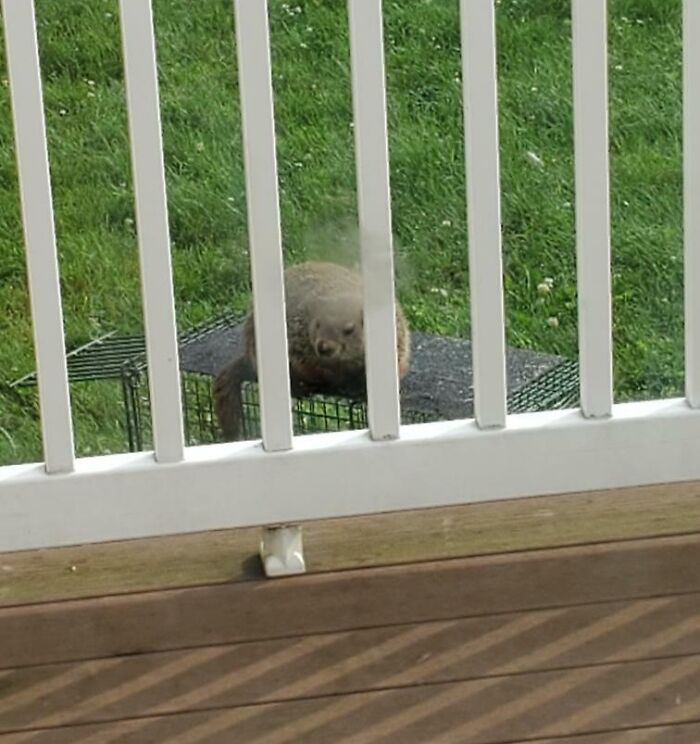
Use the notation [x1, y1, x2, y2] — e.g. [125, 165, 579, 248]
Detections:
[12, 315, 579, 452]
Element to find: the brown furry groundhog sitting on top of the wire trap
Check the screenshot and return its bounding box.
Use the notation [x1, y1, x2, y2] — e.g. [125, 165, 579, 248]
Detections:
[214, 261, 411, 441]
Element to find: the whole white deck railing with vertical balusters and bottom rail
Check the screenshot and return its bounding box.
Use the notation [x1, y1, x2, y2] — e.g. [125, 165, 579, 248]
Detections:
[0, 0, 700, 550]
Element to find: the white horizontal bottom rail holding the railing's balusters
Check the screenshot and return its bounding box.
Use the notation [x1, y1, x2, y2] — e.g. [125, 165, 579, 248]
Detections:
[0, 399, 700, 551]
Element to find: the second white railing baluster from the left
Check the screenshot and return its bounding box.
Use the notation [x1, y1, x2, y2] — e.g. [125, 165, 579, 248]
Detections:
[119, 0, 184, 462]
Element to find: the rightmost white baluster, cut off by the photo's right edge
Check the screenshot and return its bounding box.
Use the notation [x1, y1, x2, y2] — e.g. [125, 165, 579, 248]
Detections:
[683, 0, 700, 408]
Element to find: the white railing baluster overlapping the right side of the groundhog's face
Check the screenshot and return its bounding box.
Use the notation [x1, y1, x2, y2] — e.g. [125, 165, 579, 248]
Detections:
[348, 0, 401, 440]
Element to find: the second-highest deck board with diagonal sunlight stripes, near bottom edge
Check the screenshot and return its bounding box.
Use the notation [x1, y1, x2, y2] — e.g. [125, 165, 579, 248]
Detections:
[0, 656, 700, 744]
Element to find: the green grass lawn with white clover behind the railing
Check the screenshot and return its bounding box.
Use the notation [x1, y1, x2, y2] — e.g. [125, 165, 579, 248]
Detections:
[0, 0, 683, 463]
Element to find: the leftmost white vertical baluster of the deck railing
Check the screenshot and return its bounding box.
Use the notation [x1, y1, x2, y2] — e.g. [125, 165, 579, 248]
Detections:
[0, 0, 75, 474]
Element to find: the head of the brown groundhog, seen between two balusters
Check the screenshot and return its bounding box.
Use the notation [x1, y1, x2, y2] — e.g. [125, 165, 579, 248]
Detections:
[309, 295, 365, 364]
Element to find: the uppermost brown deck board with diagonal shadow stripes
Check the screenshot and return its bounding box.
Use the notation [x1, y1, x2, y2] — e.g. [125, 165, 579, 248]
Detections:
[0, 595, 700, 732]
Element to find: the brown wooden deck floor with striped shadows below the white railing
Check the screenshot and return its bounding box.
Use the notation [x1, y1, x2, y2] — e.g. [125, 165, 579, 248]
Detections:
[0, 489, 700, 744]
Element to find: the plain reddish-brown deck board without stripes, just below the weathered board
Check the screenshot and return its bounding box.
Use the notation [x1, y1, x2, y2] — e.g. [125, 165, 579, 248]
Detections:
[0, 535, 700, 668]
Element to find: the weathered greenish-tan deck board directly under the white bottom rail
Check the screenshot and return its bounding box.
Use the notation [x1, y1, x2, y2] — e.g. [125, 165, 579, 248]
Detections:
[0, 482, 700, 606]
